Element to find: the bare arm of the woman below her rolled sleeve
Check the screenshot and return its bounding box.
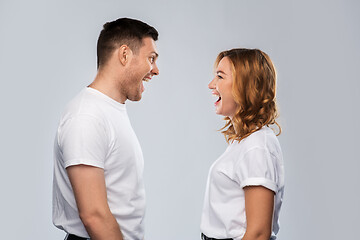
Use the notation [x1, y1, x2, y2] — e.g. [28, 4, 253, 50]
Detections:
[242, 186, 275, 240]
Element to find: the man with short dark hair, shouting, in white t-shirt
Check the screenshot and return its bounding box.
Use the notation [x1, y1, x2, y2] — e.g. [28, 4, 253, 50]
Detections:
[53, 18, 159, 240]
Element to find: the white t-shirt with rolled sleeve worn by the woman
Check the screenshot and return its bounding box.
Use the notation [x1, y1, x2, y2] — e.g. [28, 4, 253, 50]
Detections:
[200, 127, 284, 240]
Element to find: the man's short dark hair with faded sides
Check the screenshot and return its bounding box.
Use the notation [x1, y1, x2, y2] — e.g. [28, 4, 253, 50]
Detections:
[97, 18, 159, 68]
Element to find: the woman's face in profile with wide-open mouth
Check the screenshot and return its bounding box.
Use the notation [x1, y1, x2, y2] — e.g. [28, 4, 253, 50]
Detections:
[209, 57, 237, 118]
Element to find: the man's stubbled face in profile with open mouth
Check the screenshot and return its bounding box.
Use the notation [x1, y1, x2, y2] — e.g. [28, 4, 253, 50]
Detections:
[121, 37, 159, 101]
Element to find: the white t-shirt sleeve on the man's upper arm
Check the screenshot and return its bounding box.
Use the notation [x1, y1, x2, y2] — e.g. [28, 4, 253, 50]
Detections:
[58, 115, 108, 168]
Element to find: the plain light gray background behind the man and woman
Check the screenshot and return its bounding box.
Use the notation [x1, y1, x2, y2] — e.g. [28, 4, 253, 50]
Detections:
[0, 0, 360, 240]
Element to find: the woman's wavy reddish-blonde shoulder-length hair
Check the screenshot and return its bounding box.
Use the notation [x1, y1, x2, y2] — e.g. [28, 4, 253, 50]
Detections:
[215, 48, 281, 143]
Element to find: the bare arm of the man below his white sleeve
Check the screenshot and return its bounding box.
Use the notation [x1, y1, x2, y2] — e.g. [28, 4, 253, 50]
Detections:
[66, 165, 123, 240]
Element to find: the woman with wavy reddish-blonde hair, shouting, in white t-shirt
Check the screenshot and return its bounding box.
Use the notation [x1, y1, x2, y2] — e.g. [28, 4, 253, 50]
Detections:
[201, 49, 284, 240]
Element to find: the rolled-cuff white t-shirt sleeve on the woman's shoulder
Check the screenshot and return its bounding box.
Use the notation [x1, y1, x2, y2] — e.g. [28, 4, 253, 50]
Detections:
[236, 148, 278, 193]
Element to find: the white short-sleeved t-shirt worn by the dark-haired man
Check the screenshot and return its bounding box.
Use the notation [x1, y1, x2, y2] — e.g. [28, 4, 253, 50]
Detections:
[53, 88, 145, 240]
